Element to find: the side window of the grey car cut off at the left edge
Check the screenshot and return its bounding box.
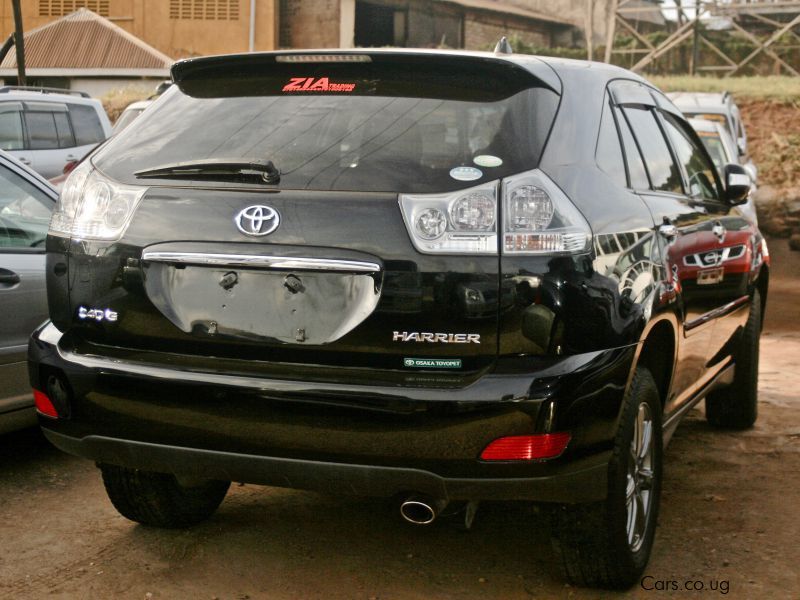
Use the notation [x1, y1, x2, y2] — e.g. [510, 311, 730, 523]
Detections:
[0, 165, 55, 248]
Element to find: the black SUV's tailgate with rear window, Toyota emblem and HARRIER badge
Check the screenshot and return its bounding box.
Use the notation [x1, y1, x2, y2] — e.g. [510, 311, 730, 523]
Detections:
[59, 54, 557, 385]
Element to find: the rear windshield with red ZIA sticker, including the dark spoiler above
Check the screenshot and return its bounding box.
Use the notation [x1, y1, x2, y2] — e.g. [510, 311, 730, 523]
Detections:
[94, 56, 558, 193]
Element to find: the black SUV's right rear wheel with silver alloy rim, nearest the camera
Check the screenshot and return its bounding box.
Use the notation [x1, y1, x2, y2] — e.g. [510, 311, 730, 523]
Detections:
[551, 367, 662, 589]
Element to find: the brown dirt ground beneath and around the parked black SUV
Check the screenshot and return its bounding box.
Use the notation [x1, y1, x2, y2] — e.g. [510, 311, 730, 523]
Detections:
[0, 240, 800, 600]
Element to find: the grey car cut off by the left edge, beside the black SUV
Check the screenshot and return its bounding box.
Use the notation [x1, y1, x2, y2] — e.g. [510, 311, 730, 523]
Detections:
[0, 150, 58, 434]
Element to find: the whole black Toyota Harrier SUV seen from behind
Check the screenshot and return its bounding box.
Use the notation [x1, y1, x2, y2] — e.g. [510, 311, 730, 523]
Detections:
[29, 50, 769, 587]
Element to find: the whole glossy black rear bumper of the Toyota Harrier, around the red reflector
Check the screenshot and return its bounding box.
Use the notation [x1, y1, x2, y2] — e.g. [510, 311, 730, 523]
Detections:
[29, 324, 635, 503]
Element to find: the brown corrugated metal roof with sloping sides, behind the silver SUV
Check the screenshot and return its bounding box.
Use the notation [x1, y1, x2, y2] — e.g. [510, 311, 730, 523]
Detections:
[0, 8, 174, 70]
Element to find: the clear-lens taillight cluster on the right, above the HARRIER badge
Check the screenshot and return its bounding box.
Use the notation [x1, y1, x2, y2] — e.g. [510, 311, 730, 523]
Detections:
[400, 169, 592, 255]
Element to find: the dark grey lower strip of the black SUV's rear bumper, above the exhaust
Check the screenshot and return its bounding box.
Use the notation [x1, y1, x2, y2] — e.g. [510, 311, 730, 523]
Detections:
[44, 427, 609, 503]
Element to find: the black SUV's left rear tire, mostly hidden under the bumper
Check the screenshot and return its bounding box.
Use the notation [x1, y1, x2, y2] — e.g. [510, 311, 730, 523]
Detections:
[98, 464, 230, 529]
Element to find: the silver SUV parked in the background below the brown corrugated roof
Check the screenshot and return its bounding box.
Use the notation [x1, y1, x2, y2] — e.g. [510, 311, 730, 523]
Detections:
[0, 86, 111, 179]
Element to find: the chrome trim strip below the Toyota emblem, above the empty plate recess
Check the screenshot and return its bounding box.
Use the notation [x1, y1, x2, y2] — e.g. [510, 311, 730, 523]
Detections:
[142, 251, 381, 273]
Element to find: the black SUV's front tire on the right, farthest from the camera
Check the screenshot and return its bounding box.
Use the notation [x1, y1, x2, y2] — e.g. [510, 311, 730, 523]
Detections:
[706, 290, 761, 429]
